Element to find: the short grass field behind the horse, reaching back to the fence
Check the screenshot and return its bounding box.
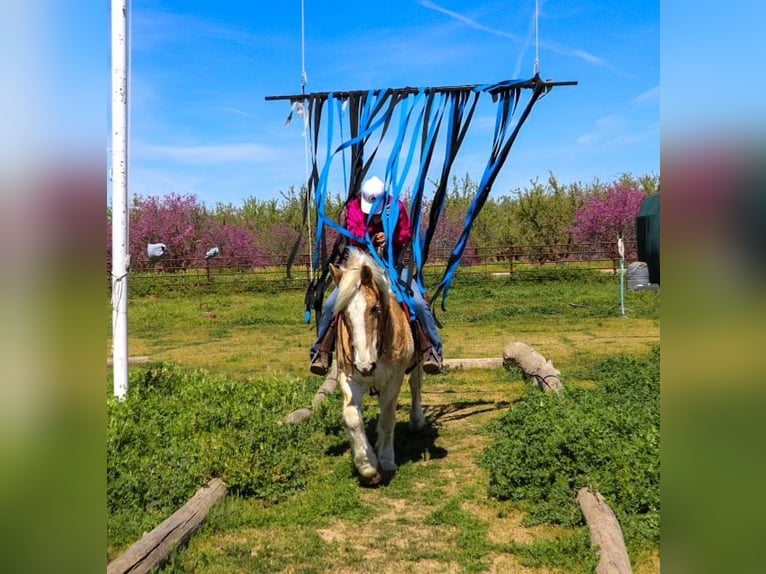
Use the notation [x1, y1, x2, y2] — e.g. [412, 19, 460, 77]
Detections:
[114, 277, 659, 377]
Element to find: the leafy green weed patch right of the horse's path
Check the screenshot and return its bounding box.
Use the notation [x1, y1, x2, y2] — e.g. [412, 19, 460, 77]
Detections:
[482, 348, 660, 551]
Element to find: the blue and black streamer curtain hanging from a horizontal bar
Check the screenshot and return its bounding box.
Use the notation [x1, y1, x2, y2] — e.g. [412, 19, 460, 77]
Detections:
[267, 75, 576, 328]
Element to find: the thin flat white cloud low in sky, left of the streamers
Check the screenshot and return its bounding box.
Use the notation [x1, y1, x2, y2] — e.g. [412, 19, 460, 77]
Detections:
[131, 143, 281, 164]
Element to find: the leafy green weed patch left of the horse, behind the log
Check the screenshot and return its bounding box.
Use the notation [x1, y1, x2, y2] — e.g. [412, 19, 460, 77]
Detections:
[107, 365, 332, 547]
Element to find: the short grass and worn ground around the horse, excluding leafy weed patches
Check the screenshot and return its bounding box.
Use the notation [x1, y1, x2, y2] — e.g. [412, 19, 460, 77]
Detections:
[107, 275, 659, 574]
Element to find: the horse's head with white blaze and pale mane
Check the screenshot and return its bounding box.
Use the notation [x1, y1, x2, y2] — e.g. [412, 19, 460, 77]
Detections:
[333, 250, 389, 376]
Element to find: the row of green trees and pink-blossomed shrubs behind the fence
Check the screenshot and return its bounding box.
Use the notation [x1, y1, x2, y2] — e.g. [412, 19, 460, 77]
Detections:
[107, 173, 660, 268]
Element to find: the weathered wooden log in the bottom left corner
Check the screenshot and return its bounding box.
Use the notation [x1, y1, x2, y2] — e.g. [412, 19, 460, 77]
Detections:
[106, 478, 226, 574]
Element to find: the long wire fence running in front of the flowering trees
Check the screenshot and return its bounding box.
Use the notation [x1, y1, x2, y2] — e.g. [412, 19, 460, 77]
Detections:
[114, 242, 636, 295]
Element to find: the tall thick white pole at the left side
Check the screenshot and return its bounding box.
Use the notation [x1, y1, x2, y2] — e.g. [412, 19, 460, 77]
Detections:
[111, 0, 130, 399]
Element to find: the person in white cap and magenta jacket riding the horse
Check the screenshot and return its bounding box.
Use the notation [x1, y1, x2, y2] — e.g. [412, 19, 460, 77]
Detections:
[309, 176, 443, 375]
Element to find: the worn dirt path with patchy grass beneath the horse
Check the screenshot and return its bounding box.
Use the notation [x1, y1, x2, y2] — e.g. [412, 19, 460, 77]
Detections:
[306, 378, 568, 574]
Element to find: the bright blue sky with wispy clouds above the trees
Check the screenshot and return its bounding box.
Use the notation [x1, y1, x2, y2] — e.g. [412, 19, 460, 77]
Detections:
[123, 0, 660, 206]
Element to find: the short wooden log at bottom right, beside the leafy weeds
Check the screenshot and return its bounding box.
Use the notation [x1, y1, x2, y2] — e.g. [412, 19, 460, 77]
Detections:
[577, 487, 633, 574]
